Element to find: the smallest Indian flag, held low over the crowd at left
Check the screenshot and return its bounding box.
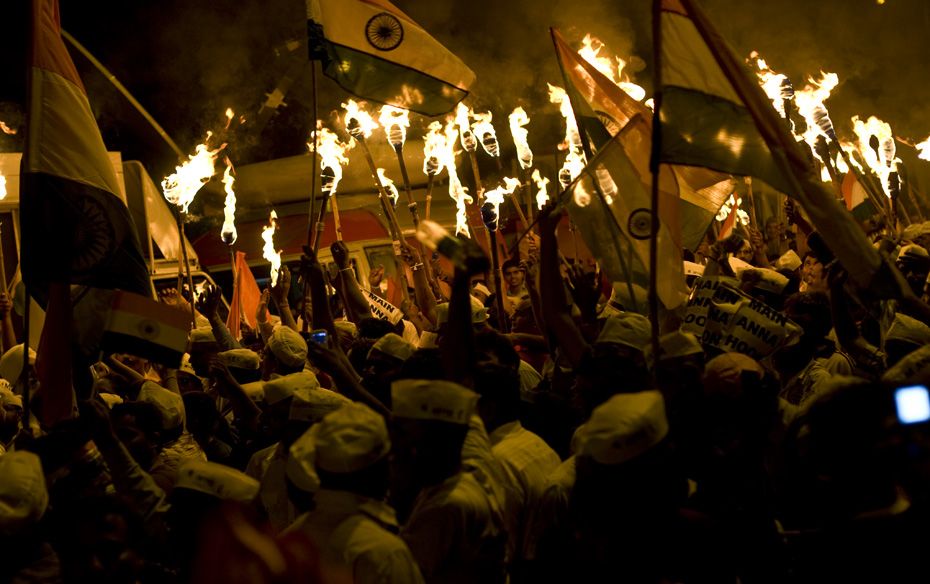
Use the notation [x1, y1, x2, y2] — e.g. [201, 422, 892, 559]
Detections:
[100, 292, 191, 368]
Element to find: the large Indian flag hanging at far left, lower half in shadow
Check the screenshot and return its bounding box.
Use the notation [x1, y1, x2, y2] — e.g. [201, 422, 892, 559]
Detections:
[20, 0, 151, 304]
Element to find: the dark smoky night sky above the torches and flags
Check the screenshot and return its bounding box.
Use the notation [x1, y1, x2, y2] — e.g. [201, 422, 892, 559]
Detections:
[0, 0, 930, 196]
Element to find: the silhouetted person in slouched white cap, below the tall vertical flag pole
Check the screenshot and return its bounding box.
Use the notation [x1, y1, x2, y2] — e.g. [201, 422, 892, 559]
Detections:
[563, 391, 687, 582]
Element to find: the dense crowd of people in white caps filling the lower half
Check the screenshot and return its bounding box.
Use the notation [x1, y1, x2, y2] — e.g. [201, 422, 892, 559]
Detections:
[0, 197, 930, 584]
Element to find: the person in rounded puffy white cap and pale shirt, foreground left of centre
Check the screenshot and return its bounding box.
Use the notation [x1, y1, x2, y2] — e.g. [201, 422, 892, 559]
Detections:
[289, 403, 423, 584]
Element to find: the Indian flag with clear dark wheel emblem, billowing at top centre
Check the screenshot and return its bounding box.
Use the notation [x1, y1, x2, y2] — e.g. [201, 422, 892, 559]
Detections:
[307, 0, 475, 116]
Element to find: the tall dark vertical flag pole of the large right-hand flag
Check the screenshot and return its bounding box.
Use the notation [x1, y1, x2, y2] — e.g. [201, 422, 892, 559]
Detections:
[648, 0, 662, 363]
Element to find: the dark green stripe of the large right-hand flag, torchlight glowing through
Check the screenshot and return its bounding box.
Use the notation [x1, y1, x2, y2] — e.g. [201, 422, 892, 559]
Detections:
[660, 86, 790, 196]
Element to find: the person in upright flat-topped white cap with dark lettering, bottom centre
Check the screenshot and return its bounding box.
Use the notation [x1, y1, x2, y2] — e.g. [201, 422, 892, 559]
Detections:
[391, 379, 506, 583]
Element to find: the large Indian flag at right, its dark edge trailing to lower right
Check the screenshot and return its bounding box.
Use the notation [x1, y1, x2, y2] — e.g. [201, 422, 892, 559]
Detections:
[653, 0, 884, 297]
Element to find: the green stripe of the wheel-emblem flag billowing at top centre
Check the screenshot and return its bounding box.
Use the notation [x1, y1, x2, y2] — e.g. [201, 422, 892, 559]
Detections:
[323, 42, 468, 116]
